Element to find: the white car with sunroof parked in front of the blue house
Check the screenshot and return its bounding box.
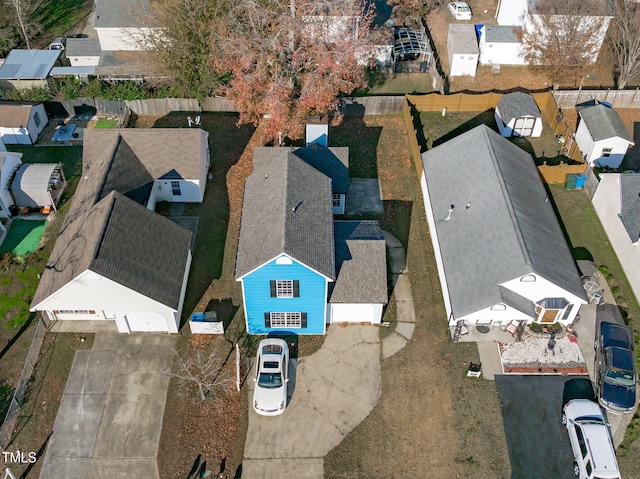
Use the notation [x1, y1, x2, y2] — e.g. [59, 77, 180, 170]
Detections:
[253, 338, 289, 416]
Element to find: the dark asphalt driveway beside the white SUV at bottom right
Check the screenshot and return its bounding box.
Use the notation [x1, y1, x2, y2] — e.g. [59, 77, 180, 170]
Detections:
[495, 375, 593, 479]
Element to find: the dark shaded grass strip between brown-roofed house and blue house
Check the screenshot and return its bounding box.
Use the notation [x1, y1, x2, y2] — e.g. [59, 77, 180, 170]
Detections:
[153, 112, 255, 323]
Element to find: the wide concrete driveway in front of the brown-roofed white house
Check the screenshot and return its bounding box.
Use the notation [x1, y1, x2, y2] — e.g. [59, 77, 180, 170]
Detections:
[40, 333, 175, 479]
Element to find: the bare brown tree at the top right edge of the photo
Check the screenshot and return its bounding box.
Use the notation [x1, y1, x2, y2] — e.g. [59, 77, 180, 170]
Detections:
[609, 0, 640, 89]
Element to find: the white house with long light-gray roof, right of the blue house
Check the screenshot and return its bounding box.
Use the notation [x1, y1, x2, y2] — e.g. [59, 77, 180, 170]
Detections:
[421, 125, 587, 340]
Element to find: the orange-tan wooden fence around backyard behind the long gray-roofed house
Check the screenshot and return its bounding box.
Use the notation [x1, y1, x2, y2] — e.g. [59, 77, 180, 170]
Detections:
[402, 91, 587, 184]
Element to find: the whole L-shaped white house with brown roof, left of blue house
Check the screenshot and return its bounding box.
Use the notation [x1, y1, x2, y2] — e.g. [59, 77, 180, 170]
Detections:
[31, 128, 209, 333]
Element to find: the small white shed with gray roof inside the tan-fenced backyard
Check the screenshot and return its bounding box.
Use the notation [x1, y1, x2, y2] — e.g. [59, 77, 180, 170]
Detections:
[495, 91, 542, 138]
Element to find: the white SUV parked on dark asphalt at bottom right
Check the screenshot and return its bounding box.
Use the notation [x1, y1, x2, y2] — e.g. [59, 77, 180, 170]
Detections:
[562, 399, 620, 479]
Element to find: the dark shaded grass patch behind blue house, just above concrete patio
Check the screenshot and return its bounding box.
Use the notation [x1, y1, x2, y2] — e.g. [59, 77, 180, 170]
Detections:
[329, 113, 382, 178]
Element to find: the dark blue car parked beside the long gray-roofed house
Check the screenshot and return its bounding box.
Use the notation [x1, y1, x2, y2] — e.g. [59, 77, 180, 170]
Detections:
[595, 321, 636, 413]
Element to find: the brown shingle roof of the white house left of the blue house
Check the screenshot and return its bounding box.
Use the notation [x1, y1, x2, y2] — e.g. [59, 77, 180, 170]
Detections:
[31, 129, 201, 309]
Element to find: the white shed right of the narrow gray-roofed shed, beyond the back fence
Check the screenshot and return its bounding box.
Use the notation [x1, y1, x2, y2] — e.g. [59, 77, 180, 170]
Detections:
[478, 25, 527, 65]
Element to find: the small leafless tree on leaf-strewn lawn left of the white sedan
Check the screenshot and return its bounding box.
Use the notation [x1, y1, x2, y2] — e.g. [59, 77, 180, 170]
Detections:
[168, 349, 234, 402]
